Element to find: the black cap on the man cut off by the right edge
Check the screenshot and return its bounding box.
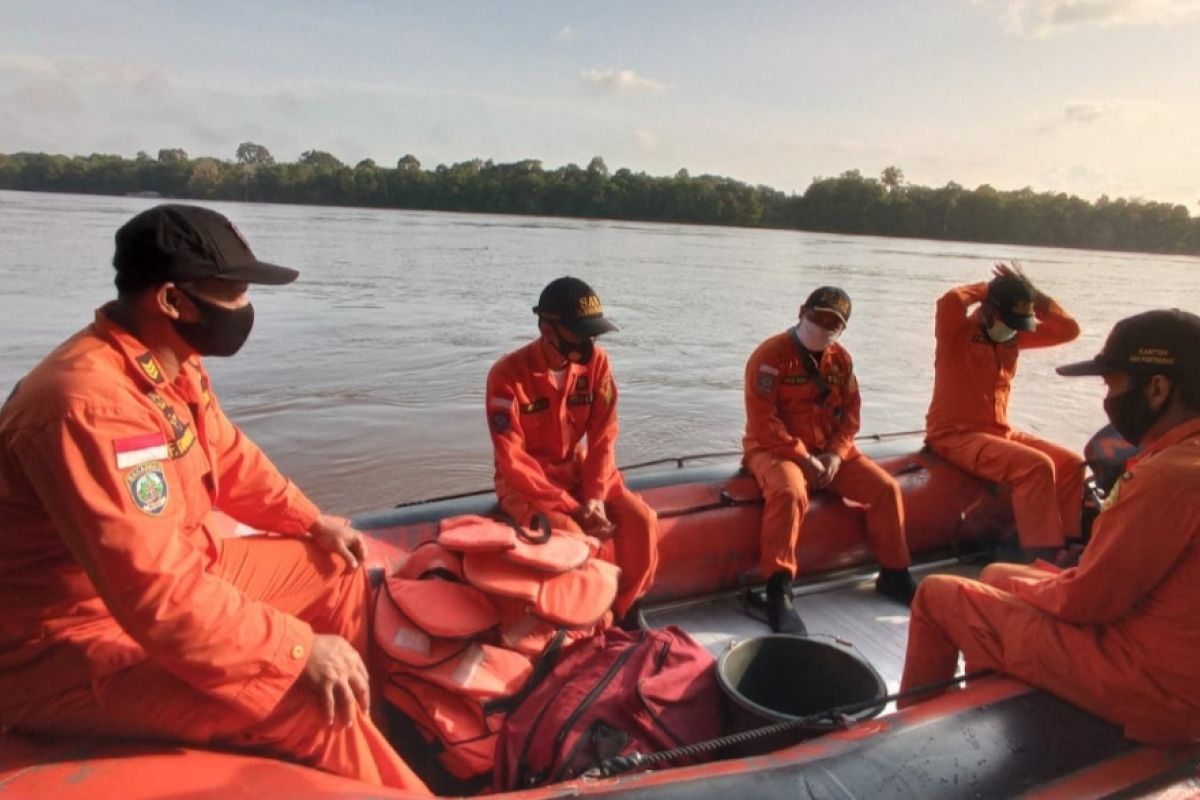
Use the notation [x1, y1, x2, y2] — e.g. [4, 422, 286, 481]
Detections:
[1055, 308, 1200, 380]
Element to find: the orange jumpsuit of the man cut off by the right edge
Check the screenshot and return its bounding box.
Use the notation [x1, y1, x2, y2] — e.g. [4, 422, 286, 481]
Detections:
[900, 420, 1200, 745]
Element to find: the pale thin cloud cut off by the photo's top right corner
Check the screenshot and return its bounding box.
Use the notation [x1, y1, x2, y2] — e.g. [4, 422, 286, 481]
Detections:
[1000, 0, 1200, 38]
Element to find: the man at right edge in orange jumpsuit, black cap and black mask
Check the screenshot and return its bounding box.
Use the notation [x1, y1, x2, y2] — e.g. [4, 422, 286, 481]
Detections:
[900, 309, 1200, 745]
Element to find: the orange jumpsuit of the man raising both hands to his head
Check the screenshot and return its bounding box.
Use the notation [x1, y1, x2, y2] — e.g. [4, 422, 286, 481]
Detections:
[925, 283, 1084, 547]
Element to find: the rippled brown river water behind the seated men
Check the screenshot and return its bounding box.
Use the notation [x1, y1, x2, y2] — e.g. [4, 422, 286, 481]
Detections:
[7, 192, 1200, 513]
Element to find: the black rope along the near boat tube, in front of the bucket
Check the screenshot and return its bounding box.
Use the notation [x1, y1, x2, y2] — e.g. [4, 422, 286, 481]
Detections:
[581, 669, 992, 780]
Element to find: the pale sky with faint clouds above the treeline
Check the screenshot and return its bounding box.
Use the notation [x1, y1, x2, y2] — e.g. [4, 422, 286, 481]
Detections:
[7, 0, 1200, 206]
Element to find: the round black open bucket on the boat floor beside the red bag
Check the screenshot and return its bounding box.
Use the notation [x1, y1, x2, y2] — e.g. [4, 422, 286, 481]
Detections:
[716, 634, 887, 733]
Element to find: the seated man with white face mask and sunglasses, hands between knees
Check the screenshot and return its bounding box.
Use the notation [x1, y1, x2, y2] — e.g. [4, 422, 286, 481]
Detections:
[742, 287, 917, 633]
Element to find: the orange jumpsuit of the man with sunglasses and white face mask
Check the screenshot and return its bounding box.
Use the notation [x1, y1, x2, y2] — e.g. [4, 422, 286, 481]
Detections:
[742, 329, 910, 577]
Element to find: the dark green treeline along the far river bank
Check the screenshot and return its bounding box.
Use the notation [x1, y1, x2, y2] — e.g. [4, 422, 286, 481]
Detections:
[0, 142, 1200, 253]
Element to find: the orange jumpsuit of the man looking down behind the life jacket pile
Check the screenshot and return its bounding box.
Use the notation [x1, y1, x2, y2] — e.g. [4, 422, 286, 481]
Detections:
[486, 339, 659, 616]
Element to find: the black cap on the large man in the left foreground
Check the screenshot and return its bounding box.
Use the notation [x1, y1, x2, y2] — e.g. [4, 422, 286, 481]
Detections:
[113, 203, 300, 287]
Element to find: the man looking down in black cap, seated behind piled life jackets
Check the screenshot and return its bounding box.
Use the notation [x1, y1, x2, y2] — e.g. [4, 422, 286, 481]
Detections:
[486, 277, 659, 630]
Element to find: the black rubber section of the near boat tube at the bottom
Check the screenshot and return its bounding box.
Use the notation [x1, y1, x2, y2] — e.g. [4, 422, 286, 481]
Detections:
[580, 692, 1138, 800]
